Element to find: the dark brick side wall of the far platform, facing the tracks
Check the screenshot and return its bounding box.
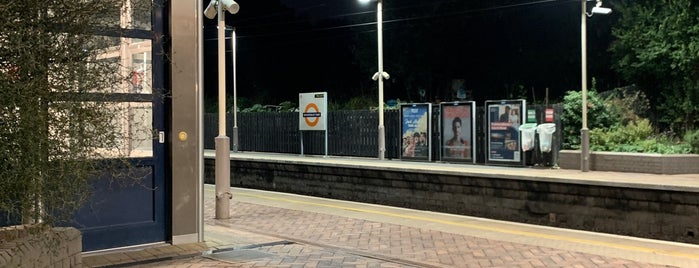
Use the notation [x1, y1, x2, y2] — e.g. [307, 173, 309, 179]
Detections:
[205, 159, 699, 244]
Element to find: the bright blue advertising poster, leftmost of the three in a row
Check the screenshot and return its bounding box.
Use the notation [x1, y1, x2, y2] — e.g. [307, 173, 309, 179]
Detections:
[400, 103, 432, 161]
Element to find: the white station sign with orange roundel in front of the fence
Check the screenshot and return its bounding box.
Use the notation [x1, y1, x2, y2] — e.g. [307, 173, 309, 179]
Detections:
[299, 92, 328, 130]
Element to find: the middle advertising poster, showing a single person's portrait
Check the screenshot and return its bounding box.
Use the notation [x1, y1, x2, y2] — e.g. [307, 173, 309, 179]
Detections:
[440, 102, 476, 162]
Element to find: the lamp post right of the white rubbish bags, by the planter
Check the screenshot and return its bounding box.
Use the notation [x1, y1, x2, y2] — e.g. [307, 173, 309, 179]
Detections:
[580, 0, 612, 172]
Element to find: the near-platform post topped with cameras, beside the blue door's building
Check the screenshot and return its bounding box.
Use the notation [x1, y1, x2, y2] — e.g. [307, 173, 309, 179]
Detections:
[204, 0, 240, 219]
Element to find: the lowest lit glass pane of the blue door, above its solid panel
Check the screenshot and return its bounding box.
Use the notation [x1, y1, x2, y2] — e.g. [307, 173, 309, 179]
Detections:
[48, 101, 158, 159]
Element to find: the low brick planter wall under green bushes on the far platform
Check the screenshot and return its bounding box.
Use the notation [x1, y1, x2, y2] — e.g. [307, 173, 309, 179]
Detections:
[558, 150, 699, 174]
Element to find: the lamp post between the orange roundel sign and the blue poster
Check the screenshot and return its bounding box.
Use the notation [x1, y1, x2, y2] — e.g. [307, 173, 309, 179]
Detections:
[359, 0, 390, 160]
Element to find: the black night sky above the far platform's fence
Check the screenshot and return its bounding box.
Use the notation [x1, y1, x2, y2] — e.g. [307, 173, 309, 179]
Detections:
[204, 0, 622, 107]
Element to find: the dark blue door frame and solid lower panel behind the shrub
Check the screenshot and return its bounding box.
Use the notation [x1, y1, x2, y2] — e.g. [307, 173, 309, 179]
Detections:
[74, 0, 171, 251]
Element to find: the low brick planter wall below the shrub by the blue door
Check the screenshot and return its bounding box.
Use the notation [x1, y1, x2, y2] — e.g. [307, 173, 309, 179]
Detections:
[0, 225, 82, 268]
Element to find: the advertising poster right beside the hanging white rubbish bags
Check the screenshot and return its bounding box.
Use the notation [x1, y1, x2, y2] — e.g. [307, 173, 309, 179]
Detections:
[485, 100, 526, 165]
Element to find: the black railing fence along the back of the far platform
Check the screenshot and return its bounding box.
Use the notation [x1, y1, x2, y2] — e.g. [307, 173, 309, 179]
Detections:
[204, 104, 563, 164]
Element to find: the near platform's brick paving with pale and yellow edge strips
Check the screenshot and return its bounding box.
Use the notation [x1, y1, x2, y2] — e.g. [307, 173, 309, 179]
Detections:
[83, 185, 699, 267]
